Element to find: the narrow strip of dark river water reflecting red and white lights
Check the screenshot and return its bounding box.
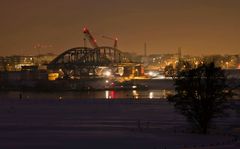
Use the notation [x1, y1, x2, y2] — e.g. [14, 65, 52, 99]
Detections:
[0, 90, 174, 100]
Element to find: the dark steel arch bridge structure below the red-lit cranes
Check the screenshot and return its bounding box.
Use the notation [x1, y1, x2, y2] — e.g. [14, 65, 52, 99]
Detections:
[48, 47, 131, 75]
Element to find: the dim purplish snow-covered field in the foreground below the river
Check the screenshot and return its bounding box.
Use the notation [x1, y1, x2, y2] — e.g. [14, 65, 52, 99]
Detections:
[0, 98, 240, 149]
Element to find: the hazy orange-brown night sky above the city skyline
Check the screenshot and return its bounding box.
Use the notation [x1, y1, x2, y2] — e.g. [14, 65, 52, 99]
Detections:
[0, 0, 240, 55]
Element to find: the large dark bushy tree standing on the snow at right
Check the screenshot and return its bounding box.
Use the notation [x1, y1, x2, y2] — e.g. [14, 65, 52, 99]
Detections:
[168, 63, 229, 134]
